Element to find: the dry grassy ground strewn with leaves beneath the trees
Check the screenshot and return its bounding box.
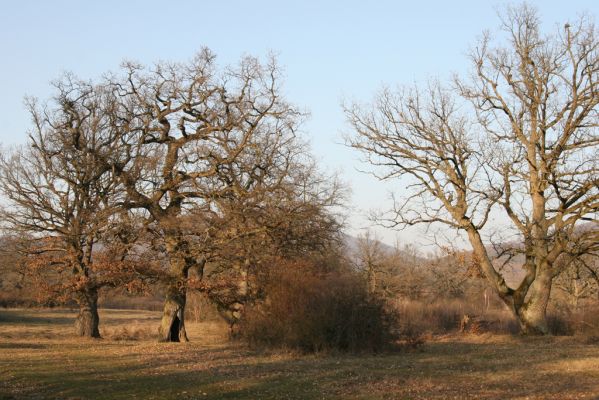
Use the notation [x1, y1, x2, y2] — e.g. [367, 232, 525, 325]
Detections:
[0, 310, 599, 399]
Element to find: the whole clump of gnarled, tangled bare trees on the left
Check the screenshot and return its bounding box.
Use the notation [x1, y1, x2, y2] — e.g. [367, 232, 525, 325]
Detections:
[0, 49, 343, 341]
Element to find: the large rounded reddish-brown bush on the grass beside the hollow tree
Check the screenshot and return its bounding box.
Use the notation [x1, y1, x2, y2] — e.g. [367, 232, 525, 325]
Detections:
[239, 262, 398, 352]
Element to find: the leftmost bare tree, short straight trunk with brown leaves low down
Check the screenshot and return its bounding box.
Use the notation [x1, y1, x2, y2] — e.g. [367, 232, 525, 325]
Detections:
[0, 76, 123, 337]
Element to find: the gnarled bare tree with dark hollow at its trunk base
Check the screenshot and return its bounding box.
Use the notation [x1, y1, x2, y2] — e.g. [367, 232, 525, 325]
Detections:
[106, 50, 302, 341]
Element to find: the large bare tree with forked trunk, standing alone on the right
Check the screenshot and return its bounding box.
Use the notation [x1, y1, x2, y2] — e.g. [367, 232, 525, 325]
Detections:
[345, 5, 599, 334]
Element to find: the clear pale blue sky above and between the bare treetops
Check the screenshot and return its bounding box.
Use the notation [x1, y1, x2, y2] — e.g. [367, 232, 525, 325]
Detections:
[0, 0, 599, 248]
